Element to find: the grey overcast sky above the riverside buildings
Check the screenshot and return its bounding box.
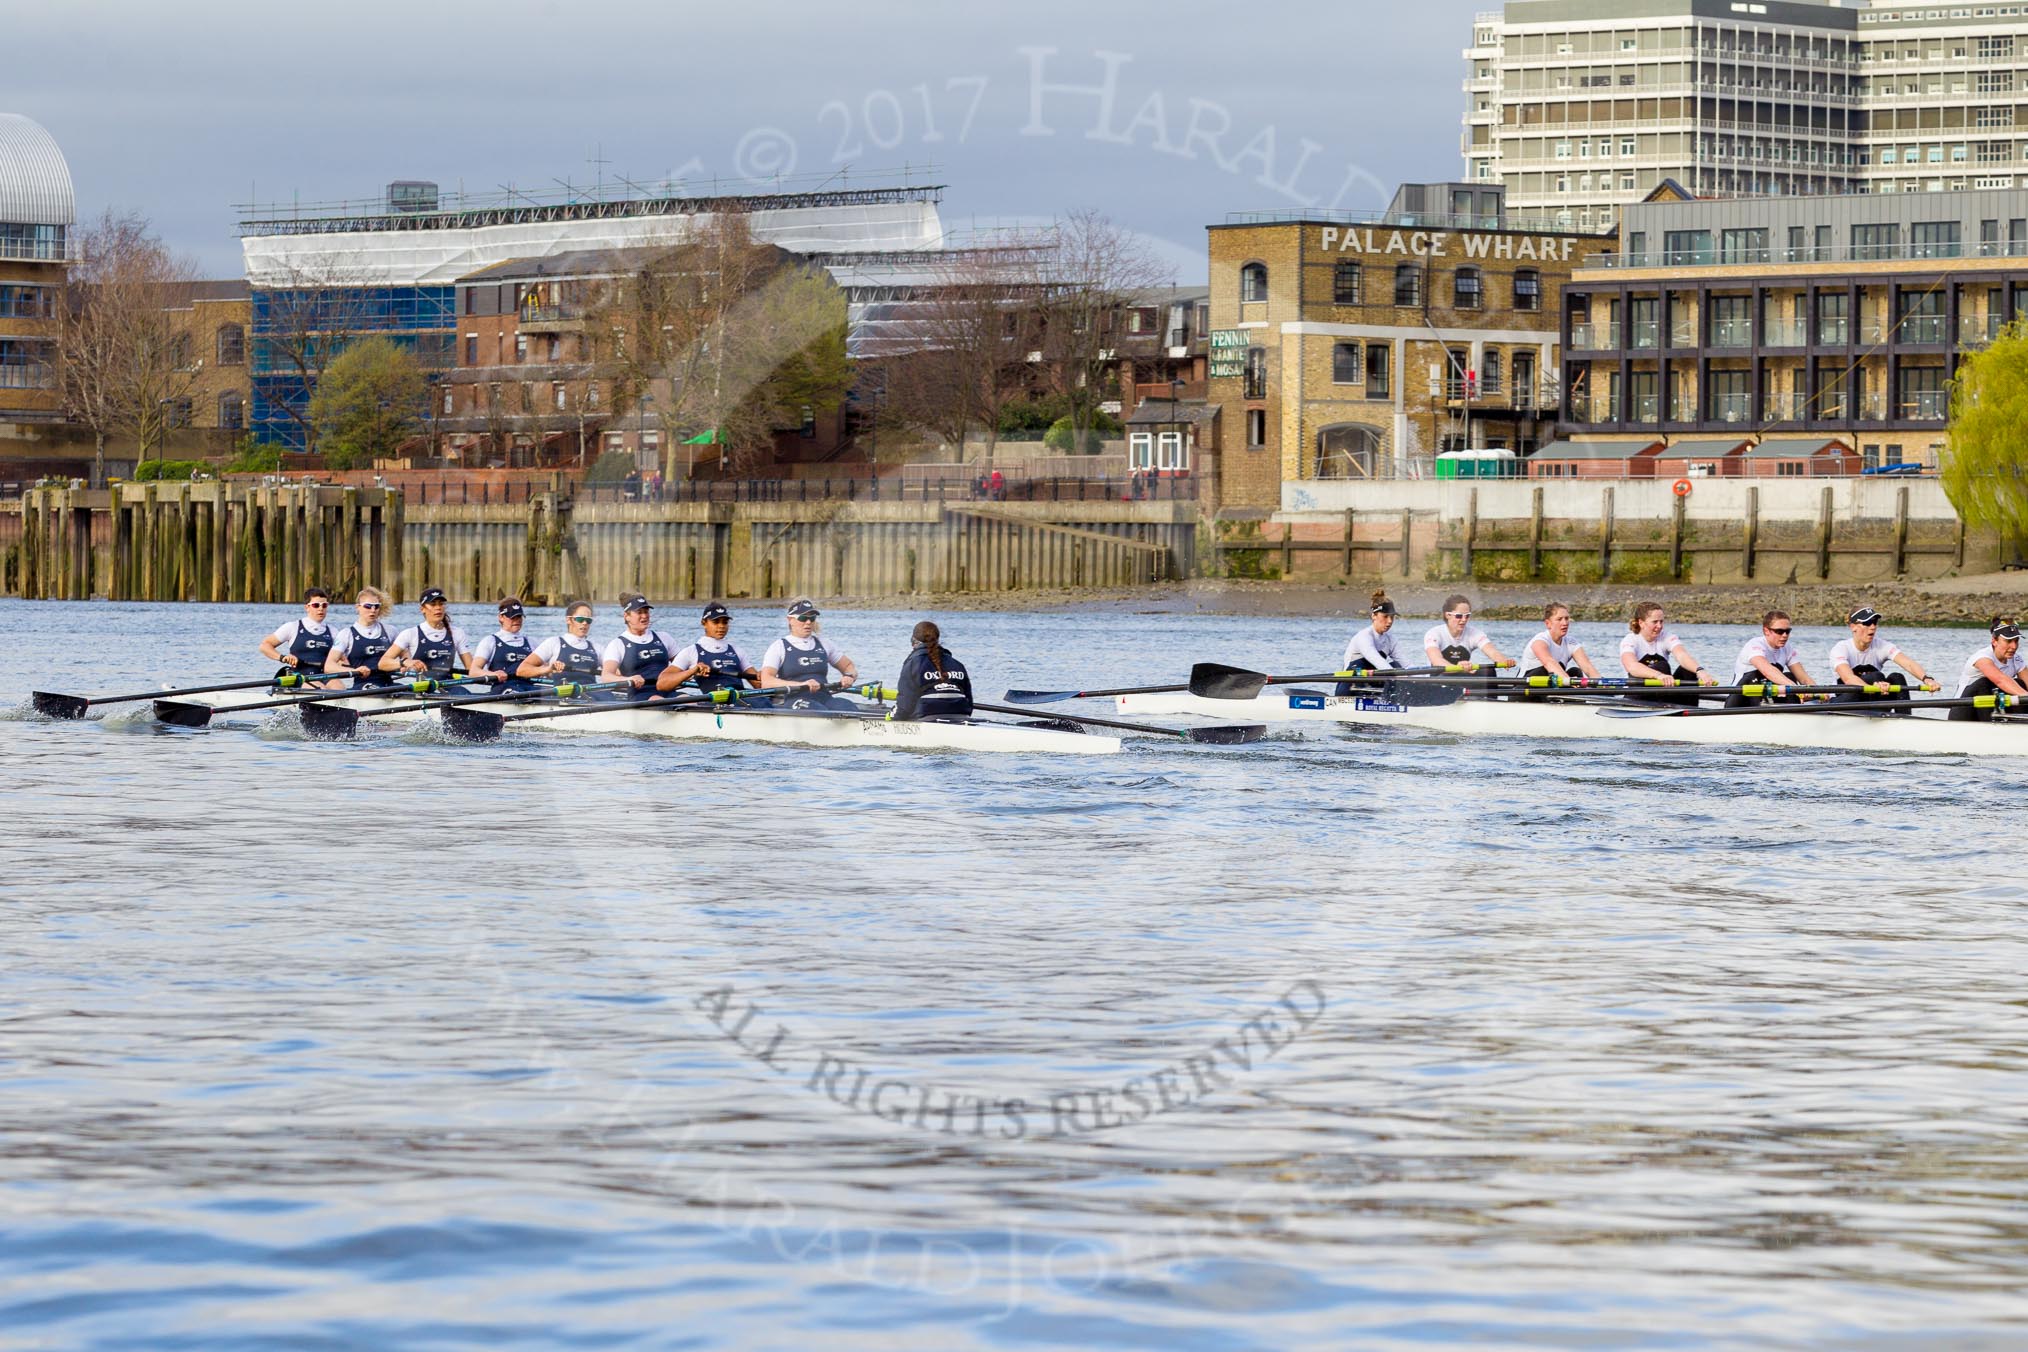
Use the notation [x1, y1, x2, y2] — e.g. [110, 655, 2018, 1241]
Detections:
[0, 0, 1493, 282]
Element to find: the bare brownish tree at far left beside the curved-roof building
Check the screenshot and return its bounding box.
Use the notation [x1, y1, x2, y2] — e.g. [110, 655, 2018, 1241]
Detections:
[57, 211, 203, 482]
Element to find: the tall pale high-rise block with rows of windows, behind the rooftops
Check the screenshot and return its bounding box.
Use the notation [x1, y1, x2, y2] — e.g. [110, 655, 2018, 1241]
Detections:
[1462, 0, 2028, 229]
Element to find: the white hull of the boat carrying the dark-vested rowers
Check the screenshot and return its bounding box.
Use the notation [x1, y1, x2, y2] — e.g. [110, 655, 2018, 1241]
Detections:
[160, 689, 1119, 756]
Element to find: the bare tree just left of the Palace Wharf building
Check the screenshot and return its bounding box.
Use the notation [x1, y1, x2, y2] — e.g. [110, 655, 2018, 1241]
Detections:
[1005, 209, 1172, 442]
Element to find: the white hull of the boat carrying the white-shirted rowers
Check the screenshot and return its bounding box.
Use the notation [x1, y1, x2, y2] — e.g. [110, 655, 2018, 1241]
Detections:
[1119, 687, 2028, 756]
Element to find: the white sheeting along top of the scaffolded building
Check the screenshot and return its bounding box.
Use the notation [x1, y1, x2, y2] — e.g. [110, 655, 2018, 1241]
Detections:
[239, 201, 943, 288]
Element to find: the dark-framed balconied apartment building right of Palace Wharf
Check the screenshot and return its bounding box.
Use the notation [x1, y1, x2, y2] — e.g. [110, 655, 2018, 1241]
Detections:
[1558, 189, 2028, 464]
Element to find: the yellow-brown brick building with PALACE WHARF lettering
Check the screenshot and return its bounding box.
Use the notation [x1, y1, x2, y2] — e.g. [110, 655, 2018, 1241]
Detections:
[1209, 184, 1614, 509]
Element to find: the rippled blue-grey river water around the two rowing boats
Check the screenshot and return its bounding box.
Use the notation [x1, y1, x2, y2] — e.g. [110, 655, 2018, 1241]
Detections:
[0, 602, 2028, 1352]
